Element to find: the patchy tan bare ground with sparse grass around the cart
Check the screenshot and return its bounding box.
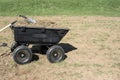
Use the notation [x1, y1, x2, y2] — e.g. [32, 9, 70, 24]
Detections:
[0, 16, 120, 80]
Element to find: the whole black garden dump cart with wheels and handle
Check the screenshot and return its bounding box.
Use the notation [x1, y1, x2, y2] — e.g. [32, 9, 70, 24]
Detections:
[1, 16, 69, 64]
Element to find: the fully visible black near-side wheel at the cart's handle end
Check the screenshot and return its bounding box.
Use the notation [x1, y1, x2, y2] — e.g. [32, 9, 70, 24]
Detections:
[13, 45, 32, 64]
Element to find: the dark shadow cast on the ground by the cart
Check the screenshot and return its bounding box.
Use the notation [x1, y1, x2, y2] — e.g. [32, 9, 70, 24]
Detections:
[31, 43, 77, 61]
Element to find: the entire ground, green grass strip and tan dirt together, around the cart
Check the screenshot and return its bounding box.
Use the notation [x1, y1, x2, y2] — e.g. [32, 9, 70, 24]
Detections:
[0, 0, 120, 80]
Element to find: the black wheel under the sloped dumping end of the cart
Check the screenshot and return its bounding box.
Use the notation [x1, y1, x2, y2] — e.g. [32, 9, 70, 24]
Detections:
[46, 45, 65, 63]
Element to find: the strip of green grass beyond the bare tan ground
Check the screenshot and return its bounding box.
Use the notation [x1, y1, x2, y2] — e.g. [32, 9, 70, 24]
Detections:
[0, 0, 120, 16]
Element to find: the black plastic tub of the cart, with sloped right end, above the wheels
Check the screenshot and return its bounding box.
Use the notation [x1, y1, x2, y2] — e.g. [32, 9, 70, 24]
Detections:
[14, 27, 68, 44]
